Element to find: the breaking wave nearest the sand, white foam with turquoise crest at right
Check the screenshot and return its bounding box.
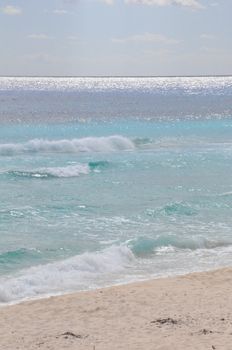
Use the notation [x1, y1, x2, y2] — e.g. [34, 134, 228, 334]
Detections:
[0, 235, 232, 303]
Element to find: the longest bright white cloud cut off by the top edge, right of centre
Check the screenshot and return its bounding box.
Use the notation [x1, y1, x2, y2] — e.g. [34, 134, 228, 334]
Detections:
[124, 0, 204, 10]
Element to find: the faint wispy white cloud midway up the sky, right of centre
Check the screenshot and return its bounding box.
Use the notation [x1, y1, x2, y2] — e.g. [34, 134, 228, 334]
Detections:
[112, 33, 180, 45]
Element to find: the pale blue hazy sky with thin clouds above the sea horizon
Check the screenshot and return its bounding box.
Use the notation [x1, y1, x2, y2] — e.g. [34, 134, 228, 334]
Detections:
[0, 0, 232, 76]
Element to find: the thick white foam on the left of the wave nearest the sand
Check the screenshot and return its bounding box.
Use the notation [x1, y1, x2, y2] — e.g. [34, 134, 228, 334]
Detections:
[0, 246, 134, 303]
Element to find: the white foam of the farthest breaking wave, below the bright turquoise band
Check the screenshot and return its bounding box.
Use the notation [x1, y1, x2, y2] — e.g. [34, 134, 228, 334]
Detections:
[0, 135, 135, 156]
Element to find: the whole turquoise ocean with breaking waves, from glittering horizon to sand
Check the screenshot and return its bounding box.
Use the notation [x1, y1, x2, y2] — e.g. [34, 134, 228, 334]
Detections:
[0, 77, 232, 303]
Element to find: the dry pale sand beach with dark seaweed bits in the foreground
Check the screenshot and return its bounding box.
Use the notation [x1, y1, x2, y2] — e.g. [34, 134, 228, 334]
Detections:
[0, 269, 232, 350]
